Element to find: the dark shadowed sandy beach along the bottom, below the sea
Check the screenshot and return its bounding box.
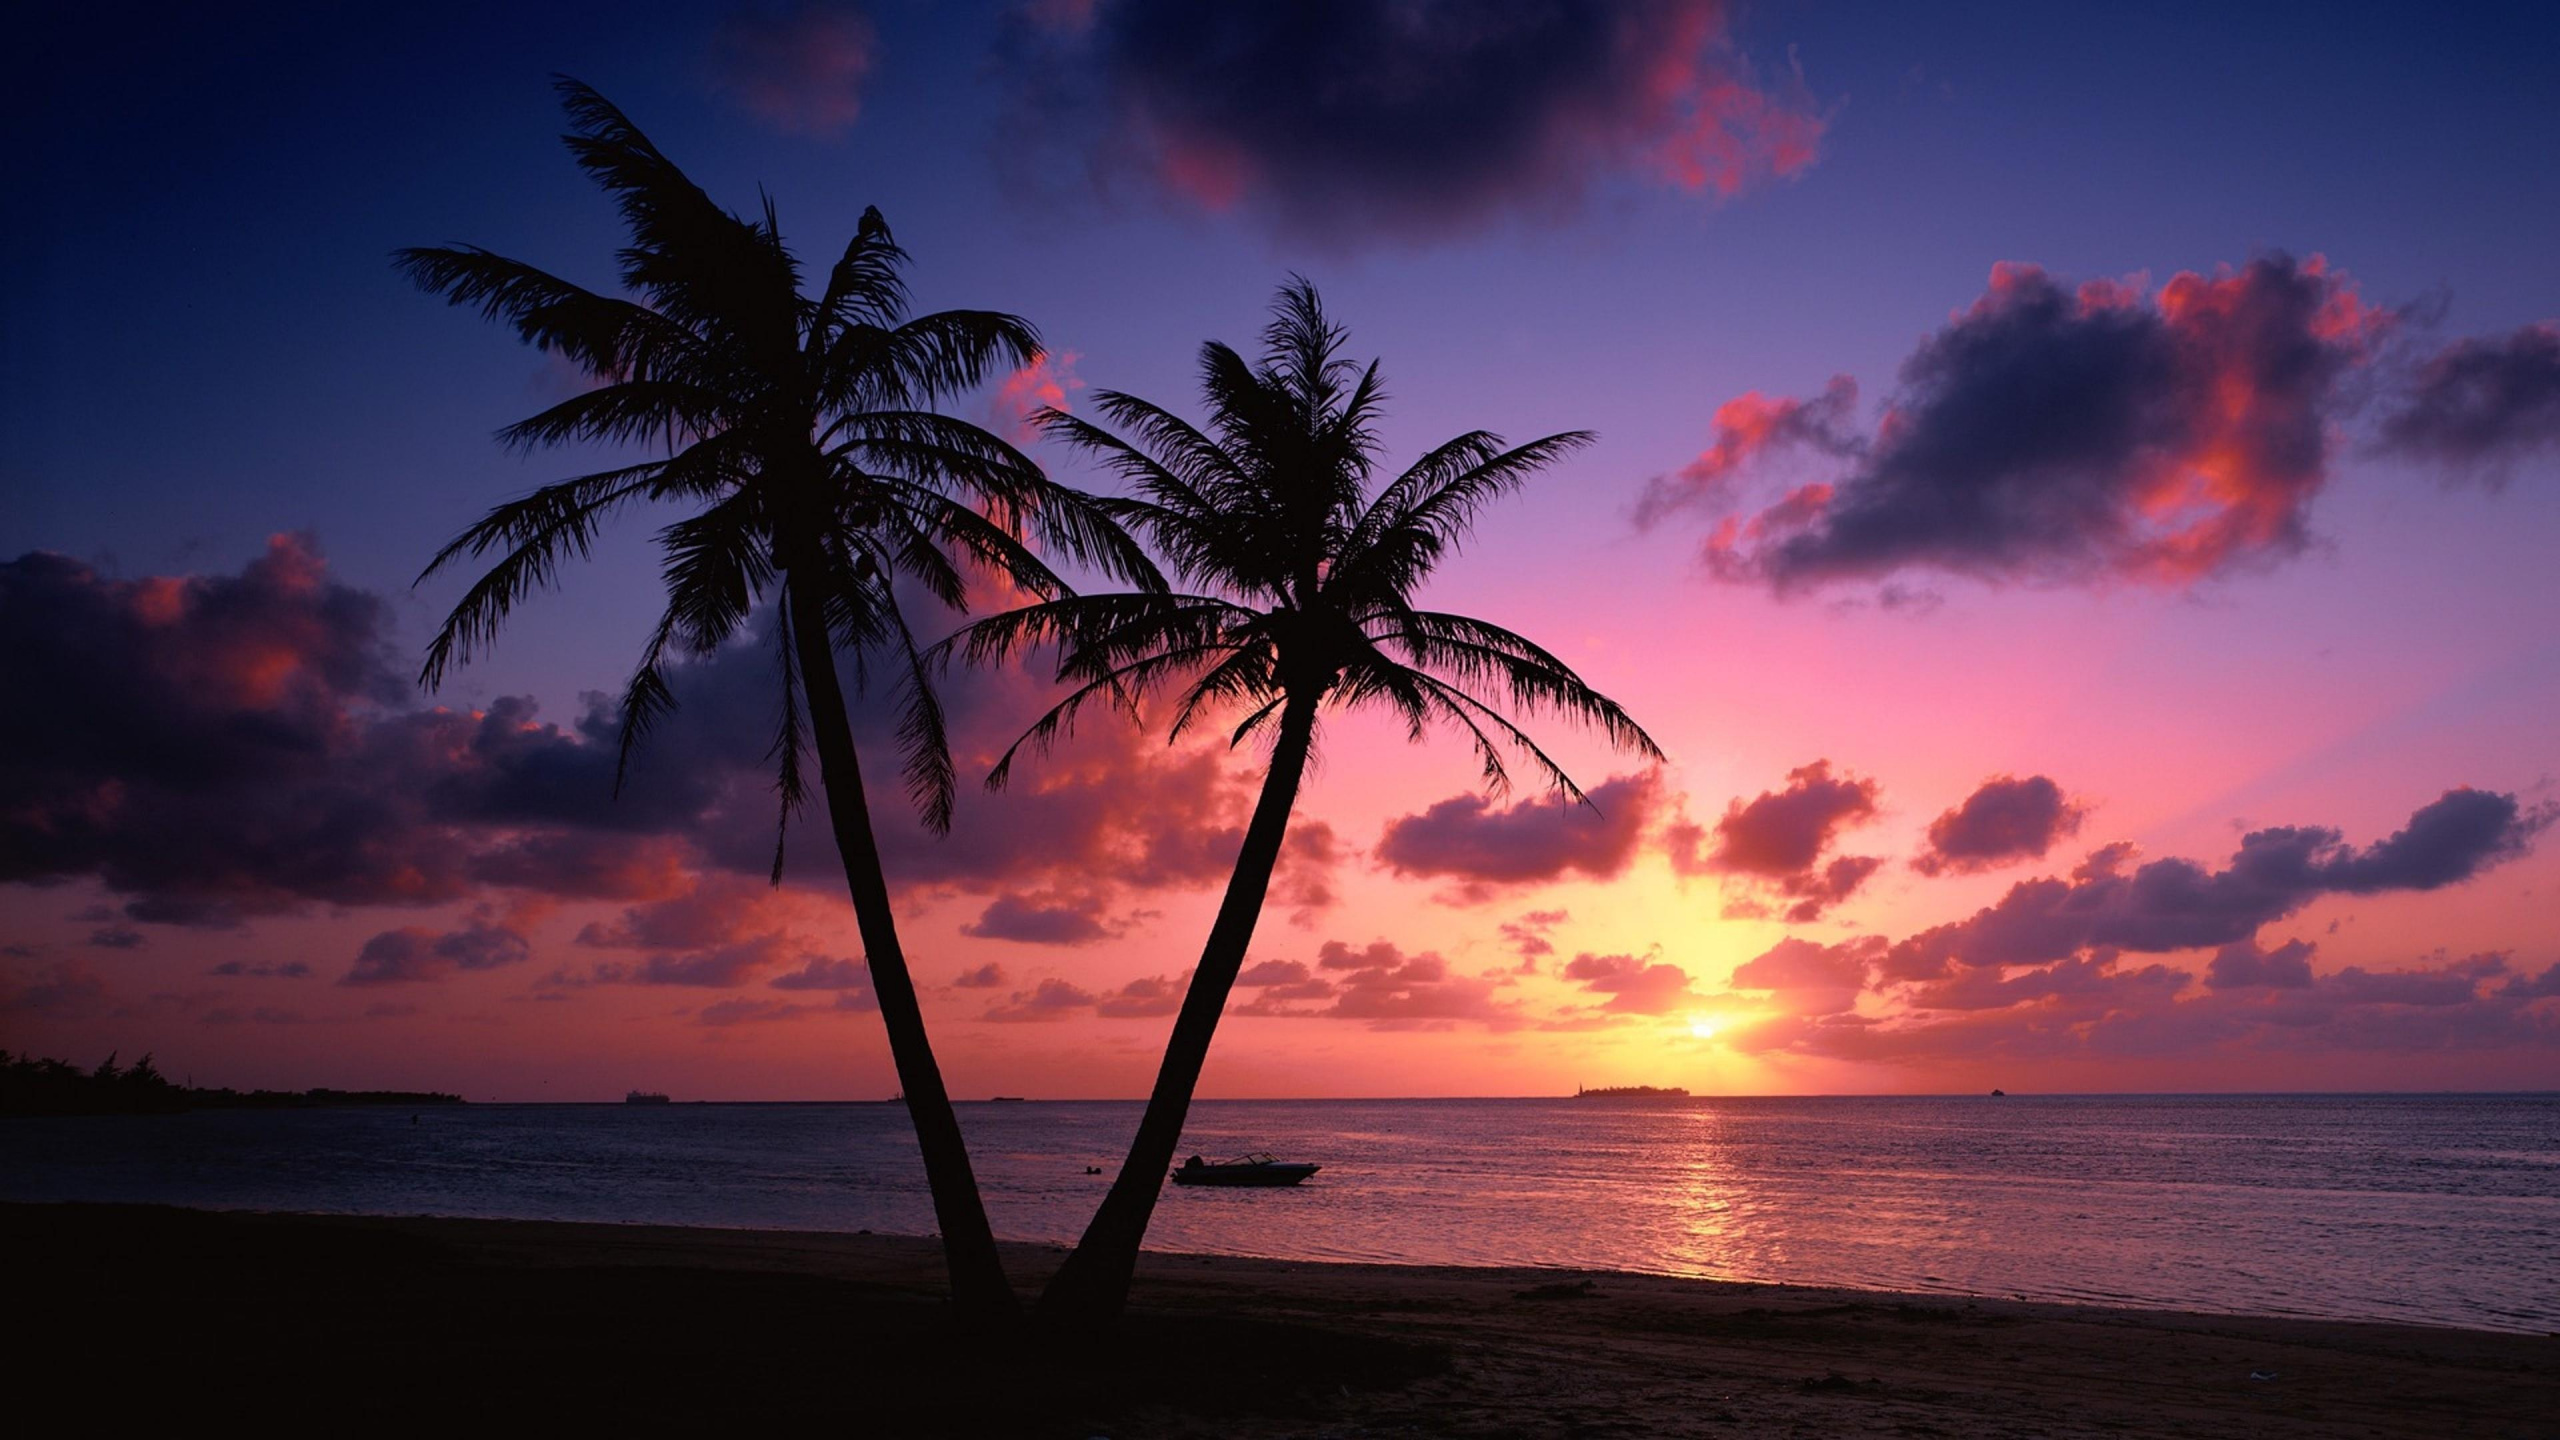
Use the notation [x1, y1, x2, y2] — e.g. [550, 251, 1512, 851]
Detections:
[15, 1204, 2560, 1440]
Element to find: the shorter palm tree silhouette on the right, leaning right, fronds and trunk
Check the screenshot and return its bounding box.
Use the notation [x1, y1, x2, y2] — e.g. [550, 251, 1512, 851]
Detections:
[947, 277, 1661, 1322]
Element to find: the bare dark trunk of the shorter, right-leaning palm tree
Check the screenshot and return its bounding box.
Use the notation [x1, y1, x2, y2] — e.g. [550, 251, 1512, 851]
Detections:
[1039, 692, 1318, 1330]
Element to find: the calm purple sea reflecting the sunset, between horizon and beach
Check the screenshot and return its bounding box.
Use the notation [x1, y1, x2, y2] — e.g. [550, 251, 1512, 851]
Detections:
[0, 1094, 2560, 1332]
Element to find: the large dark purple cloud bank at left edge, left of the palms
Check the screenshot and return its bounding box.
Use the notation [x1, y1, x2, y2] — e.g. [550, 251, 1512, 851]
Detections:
[0, 536, 717, 925]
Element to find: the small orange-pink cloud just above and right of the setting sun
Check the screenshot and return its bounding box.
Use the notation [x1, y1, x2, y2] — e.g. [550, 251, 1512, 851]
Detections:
[1667, 761, 1884, 922]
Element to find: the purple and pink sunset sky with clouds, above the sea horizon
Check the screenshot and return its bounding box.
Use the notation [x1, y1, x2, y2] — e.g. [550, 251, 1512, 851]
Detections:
[0, 0, 2560, 1099]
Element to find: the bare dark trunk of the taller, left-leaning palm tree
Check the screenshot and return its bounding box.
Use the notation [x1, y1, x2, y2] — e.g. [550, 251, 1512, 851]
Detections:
[791, 577, 1021, 1327]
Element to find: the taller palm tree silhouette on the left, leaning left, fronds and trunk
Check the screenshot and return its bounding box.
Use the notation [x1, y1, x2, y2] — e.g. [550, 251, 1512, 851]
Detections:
[397, 79, 1162, 1322]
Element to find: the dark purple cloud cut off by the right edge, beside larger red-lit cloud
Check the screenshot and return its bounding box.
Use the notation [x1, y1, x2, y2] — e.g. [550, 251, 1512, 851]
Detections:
[2381, 323, 2560, 487]
